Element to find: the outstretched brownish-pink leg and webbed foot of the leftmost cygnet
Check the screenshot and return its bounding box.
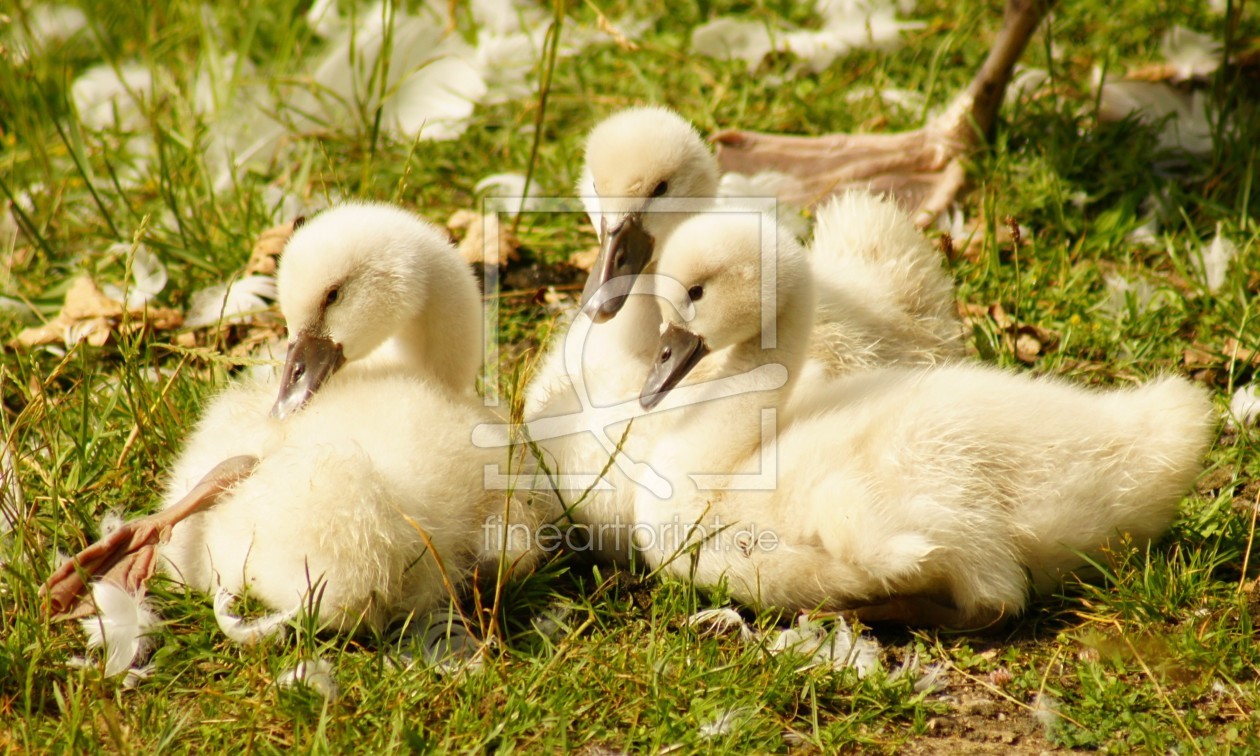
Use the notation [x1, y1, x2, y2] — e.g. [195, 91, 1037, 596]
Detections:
[39, 455, 258, 620]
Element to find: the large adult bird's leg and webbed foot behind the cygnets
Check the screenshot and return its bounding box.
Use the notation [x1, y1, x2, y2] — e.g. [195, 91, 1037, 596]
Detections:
[712, 0, 1055, 228]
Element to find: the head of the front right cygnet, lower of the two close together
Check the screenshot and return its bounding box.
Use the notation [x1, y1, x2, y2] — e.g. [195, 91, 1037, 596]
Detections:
[639, 213, 814, 410]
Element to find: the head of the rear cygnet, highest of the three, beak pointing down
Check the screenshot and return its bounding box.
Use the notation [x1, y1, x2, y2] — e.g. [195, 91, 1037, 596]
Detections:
[582, 107, 718, 323]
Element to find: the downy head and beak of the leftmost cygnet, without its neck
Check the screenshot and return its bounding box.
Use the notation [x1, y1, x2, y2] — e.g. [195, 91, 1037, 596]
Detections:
[271, 203, 454, 418]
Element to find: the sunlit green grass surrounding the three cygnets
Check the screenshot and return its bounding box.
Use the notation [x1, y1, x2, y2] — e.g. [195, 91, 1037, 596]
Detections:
[0, 0, 1260, 752]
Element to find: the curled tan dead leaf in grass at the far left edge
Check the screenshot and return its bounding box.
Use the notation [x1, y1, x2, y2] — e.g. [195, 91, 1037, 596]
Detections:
[9, 276, 184, 348]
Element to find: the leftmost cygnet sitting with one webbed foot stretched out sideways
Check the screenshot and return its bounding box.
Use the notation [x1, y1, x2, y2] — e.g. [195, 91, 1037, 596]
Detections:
[45, 204, 534, 630]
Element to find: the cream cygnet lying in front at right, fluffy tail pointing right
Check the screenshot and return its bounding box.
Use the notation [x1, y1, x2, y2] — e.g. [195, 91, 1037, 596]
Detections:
[635, 211, 1212, 629]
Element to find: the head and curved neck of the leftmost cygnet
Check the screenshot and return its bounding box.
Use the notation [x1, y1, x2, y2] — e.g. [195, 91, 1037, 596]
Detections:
[275, 204, 481, 418]
